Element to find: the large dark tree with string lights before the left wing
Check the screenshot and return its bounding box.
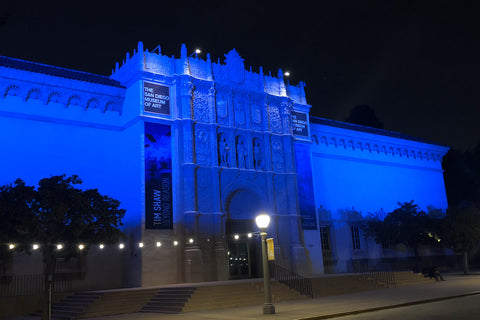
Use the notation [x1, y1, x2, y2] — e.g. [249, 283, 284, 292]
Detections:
[0, 175, 125, 318]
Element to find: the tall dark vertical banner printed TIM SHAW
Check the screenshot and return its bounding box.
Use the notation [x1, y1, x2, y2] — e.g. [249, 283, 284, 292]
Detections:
[145, 122, 173, 229]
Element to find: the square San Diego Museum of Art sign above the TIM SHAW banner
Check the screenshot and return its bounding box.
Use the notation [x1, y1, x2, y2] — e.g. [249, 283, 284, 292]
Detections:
[143, 82, 170, 115]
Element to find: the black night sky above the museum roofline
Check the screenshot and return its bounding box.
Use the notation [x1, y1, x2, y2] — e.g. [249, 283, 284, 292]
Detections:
[0, 0, 480, 150]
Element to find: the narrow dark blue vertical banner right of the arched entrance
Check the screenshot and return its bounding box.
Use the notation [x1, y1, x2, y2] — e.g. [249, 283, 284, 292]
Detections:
[295, 143, 317, 230]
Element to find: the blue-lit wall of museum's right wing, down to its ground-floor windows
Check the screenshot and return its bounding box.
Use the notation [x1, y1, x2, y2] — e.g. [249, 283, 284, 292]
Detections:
[311, 119, 448, 271]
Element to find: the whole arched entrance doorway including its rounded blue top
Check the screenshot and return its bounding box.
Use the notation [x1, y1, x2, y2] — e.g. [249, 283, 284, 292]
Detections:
[225, 188, 264, 279]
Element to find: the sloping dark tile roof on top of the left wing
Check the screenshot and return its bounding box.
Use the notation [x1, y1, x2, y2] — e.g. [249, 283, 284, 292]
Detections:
[0, 56, 124, 88]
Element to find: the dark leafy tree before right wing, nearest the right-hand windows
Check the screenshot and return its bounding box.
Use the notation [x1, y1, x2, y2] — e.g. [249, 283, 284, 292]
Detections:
[363, 200, 439, 272]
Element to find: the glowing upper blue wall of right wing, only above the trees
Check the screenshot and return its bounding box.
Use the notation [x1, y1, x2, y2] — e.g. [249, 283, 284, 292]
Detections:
[311, 120, 448, 215]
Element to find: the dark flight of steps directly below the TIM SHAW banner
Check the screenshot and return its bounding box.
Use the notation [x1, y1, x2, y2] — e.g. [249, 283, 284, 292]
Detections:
[140, 287, 195, 313]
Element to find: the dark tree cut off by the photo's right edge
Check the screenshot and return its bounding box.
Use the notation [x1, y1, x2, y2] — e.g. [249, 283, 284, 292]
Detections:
[442, 202, 480, 274]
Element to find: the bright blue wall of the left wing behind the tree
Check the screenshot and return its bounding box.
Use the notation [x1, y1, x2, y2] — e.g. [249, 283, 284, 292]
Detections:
[0, 59, 148, 288]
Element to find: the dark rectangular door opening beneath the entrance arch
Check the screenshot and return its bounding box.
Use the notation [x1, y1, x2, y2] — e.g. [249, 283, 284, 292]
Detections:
[225, 219, 261, 279]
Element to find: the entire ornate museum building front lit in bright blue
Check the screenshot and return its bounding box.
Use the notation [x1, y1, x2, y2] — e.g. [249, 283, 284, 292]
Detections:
[0, 43, 448, 288]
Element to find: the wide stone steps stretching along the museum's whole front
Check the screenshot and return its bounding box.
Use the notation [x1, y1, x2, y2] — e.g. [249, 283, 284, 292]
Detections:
[28, 271, 435, 320]
